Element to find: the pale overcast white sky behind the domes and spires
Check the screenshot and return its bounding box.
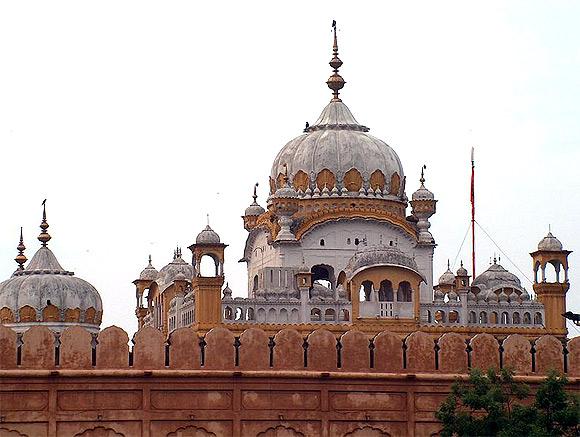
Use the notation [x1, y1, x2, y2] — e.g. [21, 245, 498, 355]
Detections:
[0, 0, 580, 335]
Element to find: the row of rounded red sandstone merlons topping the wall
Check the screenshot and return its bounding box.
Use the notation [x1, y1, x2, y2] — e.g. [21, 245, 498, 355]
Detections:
[0, 325, 580, 377]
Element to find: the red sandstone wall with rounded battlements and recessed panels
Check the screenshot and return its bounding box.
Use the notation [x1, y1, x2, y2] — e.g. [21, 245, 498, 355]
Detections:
[0, 326, 580, 437]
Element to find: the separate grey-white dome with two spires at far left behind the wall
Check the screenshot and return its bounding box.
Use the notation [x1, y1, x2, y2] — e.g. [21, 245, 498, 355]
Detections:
[0, 205, 103, 332]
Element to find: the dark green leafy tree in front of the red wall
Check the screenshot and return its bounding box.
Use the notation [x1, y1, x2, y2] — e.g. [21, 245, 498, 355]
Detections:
[435, 369, 580, 437]
